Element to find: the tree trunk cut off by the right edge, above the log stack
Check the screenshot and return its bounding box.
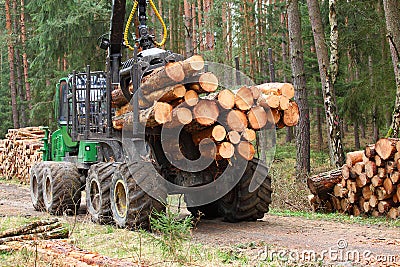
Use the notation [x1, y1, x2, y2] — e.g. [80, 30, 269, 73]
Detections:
[383, 0, 400, 137]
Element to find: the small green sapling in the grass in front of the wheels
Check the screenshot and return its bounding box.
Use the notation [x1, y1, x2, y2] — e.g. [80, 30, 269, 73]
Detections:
[150, 207, 192, 262]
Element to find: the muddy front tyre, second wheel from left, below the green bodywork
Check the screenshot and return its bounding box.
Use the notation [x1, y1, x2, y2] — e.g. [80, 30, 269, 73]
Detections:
[42, 162, 81, 215]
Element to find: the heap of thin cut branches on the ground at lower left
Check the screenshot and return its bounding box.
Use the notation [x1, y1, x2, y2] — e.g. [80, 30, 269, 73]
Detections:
[0, 219, 69, 245]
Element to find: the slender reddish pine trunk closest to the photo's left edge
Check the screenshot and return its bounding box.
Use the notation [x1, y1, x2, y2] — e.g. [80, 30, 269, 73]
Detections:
[5, 0, 19, 128]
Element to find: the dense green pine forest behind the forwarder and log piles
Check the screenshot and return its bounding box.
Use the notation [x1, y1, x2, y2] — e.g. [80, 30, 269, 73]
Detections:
[0, 0, 396, 174]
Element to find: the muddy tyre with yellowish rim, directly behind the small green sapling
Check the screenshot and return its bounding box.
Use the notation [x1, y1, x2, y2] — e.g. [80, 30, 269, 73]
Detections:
[110, 162, 167, 229]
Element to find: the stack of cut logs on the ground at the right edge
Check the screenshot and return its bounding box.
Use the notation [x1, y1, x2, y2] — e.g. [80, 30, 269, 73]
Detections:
[307, 138, 400, 219]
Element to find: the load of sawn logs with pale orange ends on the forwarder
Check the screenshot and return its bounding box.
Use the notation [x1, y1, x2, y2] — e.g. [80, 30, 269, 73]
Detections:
[112, 55, 299, 160]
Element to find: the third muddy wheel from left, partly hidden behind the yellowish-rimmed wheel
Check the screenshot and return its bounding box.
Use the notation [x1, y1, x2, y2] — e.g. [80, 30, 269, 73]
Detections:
[86, 162, 117, 224]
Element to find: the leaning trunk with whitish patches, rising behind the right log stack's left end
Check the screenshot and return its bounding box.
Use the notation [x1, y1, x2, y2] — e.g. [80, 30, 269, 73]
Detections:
[307, 0, 344, 167]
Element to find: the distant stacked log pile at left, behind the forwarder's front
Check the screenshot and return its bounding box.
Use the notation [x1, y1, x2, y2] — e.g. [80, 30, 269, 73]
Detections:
[0, 127, 44, 183]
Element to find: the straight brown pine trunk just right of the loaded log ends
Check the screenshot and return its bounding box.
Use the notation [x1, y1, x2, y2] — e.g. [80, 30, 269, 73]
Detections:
[288, 0, 310, 178]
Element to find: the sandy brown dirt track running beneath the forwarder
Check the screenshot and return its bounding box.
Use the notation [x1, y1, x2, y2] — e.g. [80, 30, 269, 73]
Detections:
[0, 183, 400, 263]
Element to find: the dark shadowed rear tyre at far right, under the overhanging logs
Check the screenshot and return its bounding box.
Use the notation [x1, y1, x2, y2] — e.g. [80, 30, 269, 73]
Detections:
[219, 159, 272, 222]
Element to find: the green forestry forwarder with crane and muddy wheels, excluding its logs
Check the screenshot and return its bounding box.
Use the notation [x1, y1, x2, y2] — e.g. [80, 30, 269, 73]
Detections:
[30, 0, 272, 229]
